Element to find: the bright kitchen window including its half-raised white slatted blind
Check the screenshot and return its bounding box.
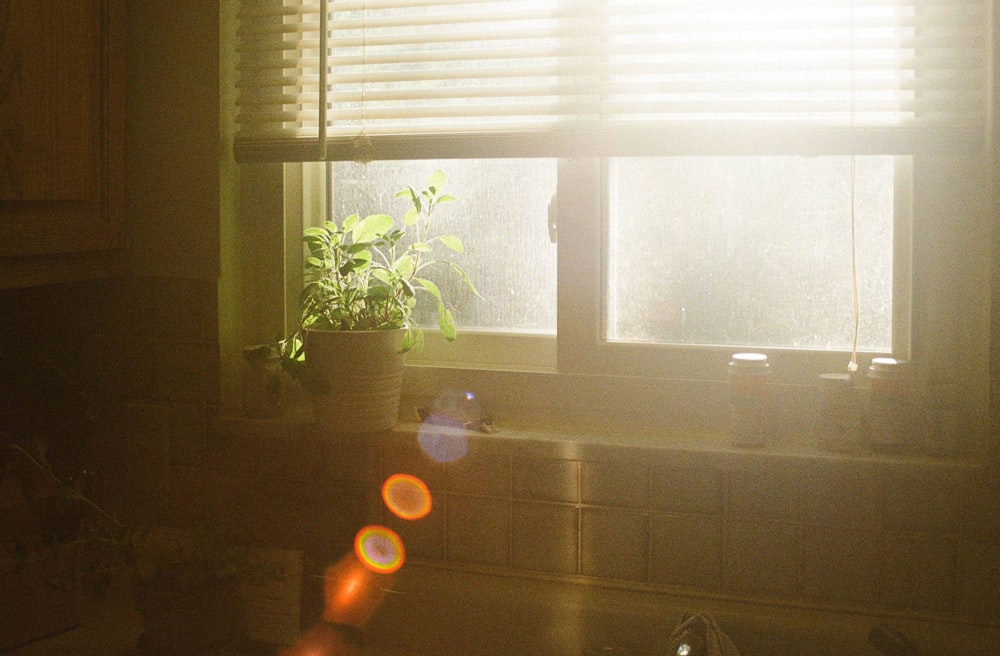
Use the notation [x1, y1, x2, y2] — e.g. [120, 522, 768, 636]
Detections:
[235, 0, 991, 452]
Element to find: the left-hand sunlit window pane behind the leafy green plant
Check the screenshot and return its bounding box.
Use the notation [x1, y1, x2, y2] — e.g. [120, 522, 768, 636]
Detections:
[332, 159, 556, 334]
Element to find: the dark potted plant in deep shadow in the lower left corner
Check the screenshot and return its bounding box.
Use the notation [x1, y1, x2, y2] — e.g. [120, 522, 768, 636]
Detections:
[3, 441, 269, 656]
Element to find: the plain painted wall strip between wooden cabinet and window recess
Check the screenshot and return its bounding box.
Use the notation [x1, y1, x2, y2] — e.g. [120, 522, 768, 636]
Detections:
[126, 0, 222, 280]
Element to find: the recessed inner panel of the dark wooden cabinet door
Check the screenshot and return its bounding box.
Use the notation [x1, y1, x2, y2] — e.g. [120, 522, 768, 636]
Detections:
[0, 0, 101, 201]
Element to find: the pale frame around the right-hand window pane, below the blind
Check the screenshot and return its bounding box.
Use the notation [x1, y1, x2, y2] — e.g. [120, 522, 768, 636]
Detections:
[557, 156, 913, 384]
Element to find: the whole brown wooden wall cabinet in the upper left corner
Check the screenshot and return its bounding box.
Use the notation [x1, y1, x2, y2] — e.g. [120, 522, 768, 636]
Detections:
[0, 0, 125, 288]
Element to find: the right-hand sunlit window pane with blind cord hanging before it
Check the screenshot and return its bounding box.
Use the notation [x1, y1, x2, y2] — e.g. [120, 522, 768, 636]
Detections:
[606, 157, 894, 351]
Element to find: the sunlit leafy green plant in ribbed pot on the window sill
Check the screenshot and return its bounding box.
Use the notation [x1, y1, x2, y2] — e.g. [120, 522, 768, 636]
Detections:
[280, 171, 479, 433]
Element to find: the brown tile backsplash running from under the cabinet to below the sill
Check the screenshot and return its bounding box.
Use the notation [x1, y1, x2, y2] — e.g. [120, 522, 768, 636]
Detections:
[0, 278, 1000, 624]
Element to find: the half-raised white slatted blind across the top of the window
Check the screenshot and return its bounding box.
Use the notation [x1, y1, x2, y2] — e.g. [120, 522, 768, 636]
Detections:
[235, 0, 990, 161]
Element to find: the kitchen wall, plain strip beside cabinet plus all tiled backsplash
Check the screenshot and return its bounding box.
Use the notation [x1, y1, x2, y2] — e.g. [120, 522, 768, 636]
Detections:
[0, 0, 1000, 644]
